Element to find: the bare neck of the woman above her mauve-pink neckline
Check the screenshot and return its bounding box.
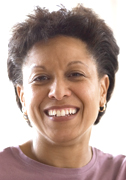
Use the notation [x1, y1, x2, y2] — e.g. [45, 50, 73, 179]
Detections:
[21, 130, 92, 168]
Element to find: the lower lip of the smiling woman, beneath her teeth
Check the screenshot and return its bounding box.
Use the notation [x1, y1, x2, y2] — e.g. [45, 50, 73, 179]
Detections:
[48, 113, 77, 122]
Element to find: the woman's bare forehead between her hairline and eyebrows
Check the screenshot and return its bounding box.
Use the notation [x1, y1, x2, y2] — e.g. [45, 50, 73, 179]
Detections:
[26, 36, 93, 66]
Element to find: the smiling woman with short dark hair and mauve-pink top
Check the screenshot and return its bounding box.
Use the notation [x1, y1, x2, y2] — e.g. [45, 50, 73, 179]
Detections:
[0, 5, 126, 180]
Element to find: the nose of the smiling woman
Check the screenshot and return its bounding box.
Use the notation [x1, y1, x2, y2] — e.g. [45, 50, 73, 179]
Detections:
[48, 80, 71, 100]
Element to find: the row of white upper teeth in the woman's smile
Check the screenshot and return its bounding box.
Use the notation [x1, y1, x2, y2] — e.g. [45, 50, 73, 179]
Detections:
[48, 108, 77, 117]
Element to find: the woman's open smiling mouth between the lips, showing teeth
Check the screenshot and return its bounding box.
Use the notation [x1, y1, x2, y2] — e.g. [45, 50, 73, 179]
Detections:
[45, 108, 79, 117]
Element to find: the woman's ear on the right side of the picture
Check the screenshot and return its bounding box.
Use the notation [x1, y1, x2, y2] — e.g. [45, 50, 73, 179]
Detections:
[100, 75, 110, 107]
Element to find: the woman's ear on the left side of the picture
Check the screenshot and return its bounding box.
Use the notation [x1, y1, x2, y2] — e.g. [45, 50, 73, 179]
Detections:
[16, 85, 27, 114]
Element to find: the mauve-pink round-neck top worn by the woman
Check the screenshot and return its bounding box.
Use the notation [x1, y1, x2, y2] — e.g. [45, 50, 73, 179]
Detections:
[0, 146, 126, 180]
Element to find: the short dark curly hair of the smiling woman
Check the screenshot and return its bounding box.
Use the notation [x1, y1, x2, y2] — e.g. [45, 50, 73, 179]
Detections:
[7, 4, 119, 124]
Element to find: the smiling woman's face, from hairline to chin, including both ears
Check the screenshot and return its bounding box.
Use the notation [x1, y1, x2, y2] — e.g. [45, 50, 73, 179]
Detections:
[17, 36, 108, 143]
